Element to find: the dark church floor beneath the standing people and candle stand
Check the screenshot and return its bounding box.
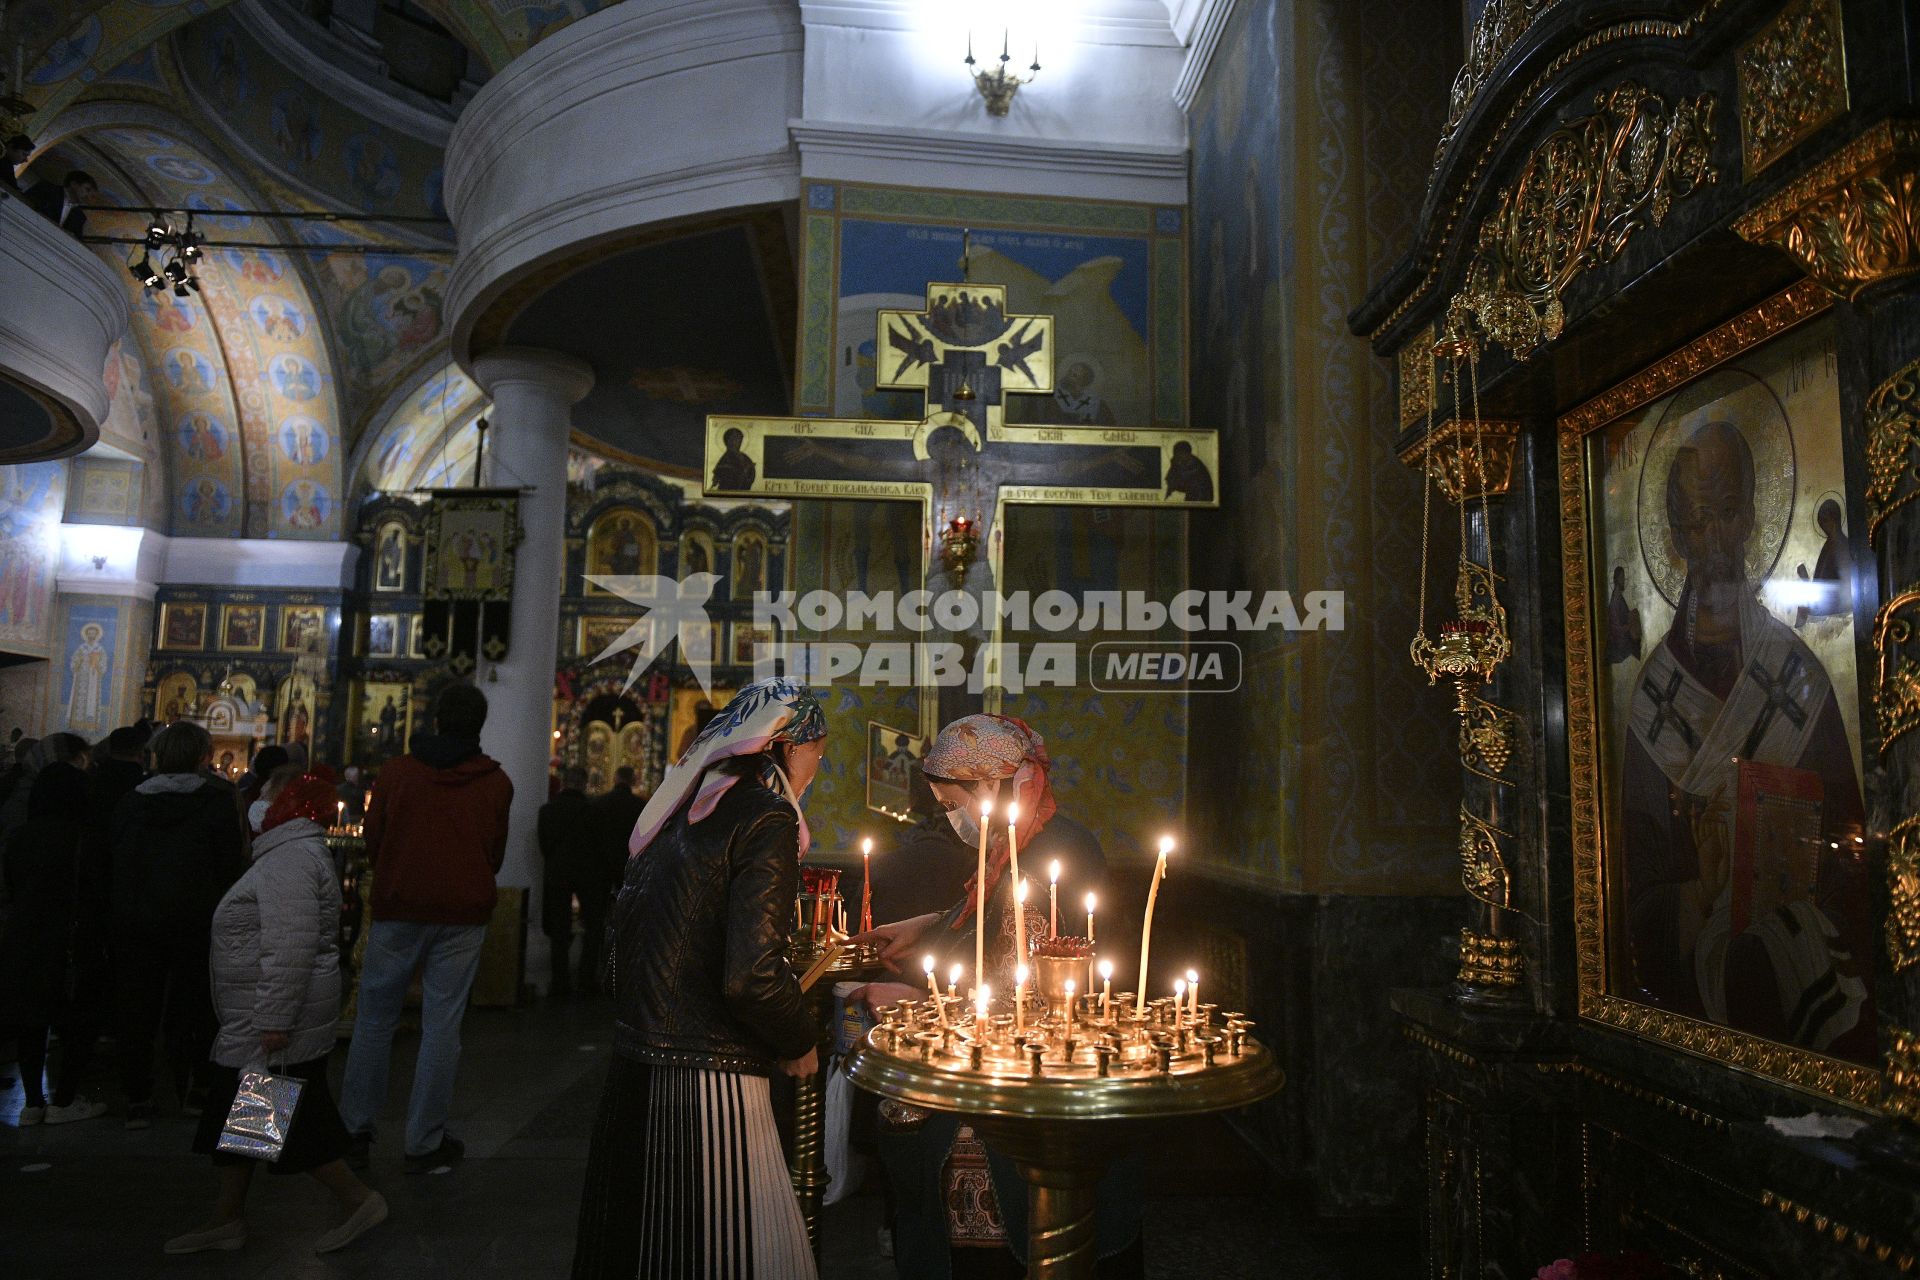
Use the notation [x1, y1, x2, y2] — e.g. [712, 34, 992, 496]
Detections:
[0, 1000, 1419, 1280]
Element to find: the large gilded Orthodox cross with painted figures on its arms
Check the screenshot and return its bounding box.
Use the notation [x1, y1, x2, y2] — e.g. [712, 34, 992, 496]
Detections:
[705, 282, 1219, 722]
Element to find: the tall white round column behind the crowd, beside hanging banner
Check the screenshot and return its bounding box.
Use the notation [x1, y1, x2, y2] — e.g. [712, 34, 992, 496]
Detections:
[470, 347, 593, 988]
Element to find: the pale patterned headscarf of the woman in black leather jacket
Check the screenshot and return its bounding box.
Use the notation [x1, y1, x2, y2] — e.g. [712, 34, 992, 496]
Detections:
[626, 677, 828, 856]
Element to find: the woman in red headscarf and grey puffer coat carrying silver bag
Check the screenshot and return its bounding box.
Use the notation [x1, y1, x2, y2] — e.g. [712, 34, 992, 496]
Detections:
[165, 766, 386, 1253]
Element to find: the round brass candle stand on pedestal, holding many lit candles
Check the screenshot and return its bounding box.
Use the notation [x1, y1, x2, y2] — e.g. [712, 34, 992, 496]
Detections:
[847, 990, 1283, 1280]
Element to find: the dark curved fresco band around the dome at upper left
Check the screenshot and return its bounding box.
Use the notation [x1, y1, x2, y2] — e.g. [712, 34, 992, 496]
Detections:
[175, 13, 444, 215]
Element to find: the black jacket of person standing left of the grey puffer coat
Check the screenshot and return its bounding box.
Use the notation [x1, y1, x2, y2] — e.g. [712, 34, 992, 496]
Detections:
[111, 773, 246, 933]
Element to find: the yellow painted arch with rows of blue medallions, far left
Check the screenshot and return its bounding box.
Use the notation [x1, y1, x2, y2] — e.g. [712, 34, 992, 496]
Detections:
[92, 124, 340, 537]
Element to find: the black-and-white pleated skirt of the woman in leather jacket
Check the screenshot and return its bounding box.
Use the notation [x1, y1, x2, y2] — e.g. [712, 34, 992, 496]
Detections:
[574, 1057, 818, 1280]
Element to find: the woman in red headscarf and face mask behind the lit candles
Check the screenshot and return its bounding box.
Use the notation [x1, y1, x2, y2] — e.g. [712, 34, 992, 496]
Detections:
[860, 716, 1142, 1280]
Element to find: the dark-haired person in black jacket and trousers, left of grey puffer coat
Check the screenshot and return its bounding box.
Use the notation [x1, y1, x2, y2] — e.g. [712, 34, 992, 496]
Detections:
[111, 720, 246, 1128]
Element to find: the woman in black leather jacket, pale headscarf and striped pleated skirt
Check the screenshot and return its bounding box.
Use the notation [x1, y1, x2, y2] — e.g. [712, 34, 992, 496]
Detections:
[574, 679, 828, 1280]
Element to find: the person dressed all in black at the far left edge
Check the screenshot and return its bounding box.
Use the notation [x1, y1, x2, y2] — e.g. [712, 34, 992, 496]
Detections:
[0, 733, 108, 1128]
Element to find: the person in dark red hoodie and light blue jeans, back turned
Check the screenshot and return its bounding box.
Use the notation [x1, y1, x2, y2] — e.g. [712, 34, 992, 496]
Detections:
[340, 685, 513, 1173]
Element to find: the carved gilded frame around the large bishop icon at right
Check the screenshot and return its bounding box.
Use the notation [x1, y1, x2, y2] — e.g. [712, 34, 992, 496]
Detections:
[1557, 280, 1882, 1105]
